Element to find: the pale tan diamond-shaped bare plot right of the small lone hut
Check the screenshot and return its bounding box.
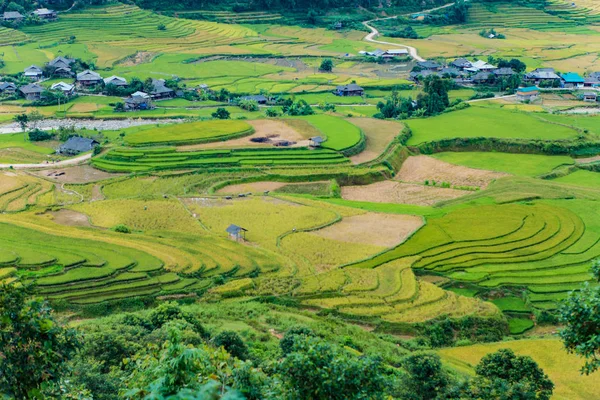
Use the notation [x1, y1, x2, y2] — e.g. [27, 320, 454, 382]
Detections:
[312, 213, 423, 247]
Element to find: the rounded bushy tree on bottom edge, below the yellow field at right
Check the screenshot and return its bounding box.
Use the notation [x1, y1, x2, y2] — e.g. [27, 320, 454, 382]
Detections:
[470, 349, 554, 400]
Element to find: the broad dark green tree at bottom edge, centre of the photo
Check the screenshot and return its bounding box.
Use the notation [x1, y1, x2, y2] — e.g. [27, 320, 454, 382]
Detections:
[278, 336, 386, 400]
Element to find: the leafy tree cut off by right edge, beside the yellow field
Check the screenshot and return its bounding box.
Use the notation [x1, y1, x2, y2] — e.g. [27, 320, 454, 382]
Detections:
[560, 260, 600, 375]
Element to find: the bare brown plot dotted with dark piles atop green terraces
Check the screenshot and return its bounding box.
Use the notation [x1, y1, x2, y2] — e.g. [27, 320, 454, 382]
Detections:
[180, 119, 308, 151]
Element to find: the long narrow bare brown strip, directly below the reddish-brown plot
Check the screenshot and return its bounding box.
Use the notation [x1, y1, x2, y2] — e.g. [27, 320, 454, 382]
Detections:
[342, 181, 472, 206]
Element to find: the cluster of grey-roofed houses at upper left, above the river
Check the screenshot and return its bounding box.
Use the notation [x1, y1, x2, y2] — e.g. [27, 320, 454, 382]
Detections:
[0, 56, 183, 110]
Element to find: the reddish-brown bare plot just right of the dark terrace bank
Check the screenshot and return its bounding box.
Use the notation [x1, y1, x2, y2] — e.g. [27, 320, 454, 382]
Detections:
[396, 156, 507, 189]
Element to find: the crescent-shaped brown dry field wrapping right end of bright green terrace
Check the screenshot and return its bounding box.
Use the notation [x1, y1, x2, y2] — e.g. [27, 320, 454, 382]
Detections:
[348, 118, 404, 164]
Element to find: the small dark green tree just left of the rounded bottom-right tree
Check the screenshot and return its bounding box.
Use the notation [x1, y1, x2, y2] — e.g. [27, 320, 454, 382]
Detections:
[402, 353, 449, 400]
